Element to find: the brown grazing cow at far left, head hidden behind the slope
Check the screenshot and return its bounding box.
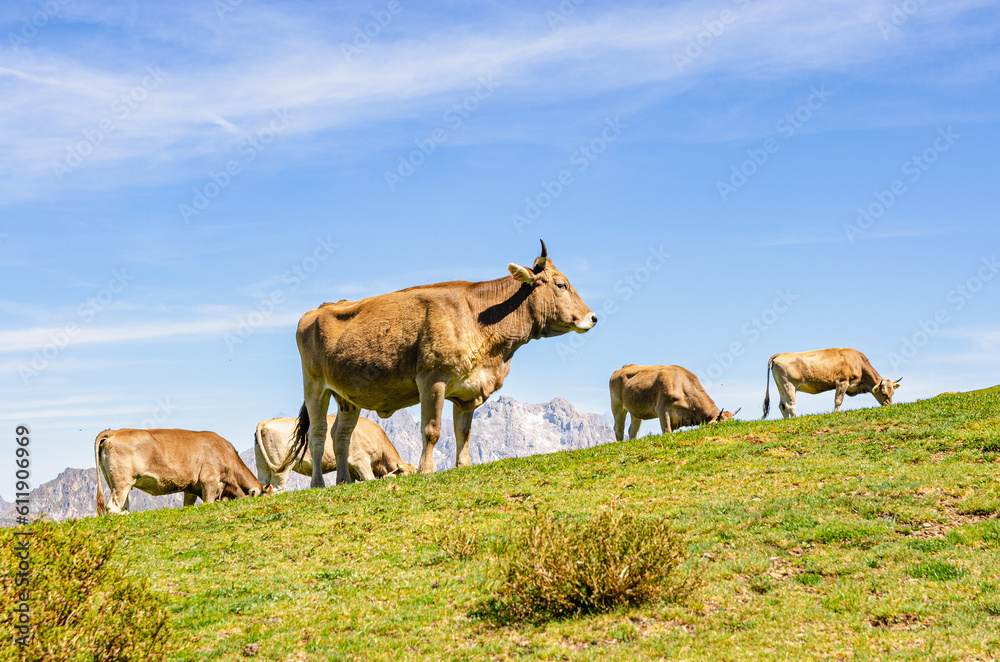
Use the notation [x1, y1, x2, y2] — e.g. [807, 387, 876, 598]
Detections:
[94, 428, 273, 515]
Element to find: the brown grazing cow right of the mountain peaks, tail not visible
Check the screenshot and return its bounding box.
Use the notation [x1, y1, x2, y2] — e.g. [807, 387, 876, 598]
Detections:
[609, 364, 740, 441]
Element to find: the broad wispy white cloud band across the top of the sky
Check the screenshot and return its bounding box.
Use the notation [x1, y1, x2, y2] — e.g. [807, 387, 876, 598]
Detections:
[0, 0, 983, 199]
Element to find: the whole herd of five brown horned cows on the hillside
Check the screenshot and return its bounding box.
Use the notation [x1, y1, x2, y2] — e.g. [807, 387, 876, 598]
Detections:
[94, 242, 899, 514]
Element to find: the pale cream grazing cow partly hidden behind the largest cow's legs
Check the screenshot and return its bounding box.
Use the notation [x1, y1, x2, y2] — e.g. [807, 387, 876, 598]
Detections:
[254, 414, 417, 492]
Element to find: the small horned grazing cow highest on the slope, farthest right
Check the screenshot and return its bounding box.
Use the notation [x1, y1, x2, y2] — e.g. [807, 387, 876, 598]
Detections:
[764, 347, 900, 418]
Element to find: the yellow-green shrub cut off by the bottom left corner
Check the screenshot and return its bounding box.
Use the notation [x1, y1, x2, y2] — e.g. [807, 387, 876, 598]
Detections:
[0, 521, 170, 662]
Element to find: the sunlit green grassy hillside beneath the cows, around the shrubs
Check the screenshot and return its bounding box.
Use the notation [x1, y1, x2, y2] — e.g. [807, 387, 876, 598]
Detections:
[3, 389, 1000, 660]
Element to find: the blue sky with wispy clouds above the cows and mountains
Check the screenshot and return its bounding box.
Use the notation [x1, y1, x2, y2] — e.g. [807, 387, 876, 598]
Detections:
[0, 0, 1000, 500]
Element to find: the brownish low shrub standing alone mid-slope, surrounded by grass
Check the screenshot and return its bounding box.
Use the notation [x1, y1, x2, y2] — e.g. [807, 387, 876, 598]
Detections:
[473, 509, 697, 622]
